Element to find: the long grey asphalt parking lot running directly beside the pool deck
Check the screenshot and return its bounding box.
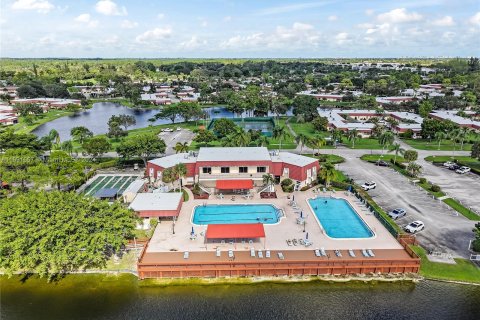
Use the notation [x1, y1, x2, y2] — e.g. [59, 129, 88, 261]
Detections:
[338, 154, 478, 258]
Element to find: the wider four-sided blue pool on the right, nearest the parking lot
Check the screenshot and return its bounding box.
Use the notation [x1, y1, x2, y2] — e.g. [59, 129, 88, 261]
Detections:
[308, 198, 373, 239]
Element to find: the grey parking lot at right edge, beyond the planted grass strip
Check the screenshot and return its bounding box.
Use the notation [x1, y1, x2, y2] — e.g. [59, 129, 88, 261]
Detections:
[418, 159, 480, 212]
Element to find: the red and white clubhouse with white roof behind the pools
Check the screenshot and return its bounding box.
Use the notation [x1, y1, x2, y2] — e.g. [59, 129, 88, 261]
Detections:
[147, 147, 320, 193]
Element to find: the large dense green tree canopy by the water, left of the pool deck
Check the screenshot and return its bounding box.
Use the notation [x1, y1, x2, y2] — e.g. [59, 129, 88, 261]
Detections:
[0, 191, 137, 277]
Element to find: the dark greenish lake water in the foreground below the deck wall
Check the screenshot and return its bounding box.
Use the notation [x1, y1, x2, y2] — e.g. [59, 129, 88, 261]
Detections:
[0, 275, 480, 320]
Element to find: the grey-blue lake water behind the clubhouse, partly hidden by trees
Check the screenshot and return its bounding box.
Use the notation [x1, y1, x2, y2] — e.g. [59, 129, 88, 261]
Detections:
[32, 102, 291, 141]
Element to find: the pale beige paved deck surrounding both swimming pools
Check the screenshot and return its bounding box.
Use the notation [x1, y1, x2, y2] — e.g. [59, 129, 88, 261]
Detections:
[147, 190, 403, 253]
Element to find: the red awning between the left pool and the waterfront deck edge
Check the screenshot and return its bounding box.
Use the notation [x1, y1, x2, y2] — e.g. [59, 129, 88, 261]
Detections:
[206, 223, 265, 239]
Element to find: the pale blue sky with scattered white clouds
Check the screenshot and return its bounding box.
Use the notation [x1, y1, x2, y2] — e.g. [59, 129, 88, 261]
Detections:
[0, 0, 480, 58]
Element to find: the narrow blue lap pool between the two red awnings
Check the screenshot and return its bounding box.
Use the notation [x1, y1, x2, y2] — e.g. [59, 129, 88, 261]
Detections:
[193, 204, 280, 225]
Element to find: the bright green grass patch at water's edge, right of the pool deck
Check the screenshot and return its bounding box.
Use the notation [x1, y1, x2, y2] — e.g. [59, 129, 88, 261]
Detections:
[412, 246, 480, 283]
